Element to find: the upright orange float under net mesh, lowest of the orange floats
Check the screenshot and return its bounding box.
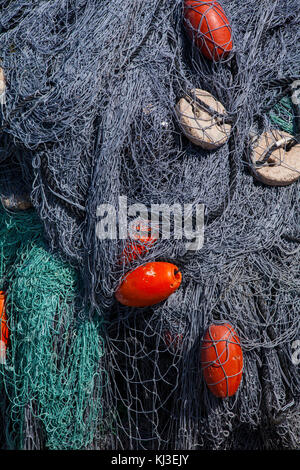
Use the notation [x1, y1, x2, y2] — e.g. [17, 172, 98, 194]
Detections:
[201, 323, 243, 398]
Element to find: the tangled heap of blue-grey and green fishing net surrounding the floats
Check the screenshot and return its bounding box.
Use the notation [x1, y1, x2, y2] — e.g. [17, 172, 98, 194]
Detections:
[0, 0, 300, 449]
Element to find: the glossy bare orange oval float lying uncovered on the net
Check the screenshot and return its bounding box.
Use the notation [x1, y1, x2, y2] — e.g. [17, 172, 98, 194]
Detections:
[115, 261, 182, 307]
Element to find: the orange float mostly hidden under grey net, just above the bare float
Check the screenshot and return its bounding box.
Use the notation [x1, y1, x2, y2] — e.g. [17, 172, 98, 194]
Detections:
[122, 222, 157, 264]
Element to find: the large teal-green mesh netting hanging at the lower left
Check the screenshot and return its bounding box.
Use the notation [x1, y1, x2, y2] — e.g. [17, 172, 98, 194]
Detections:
[0, 210, 106, 449]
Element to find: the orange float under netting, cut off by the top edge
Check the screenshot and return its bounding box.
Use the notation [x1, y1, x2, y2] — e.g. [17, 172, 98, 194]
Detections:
[184, 0, 233, 61]
